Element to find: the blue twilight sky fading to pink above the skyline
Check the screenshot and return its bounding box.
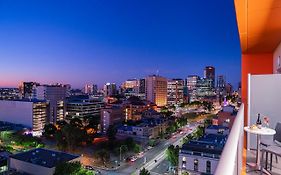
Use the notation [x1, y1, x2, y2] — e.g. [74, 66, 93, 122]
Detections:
[0, 0, 240, 88]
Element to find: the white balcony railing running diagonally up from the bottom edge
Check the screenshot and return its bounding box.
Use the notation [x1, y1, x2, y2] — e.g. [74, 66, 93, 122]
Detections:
[215, 104, 244, 175]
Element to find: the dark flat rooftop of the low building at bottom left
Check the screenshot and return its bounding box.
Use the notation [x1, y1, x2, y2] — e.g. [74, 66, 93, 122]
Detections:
[11, 148, 80, 168]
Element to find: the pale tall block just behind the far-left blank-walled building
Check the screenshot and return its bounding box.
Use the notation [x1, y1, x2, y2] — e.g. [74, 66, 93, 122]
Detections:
[36, 84, 67, 123]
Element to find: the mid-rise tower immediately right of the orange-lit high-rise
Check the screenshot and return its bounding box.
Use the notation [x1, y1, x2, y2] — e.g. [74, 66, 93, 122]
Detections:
[167, 79, 184, 105]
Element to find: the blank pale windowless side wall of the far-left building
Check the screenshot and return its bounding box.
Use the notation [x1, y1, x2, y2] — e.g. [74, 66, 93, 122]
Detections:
[0, 100, 33, 128]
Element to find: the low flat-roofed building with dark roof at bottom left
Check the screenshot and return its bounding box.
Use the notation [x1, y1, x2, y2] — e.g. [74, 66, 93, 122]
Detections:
[8, 148, 80, 175]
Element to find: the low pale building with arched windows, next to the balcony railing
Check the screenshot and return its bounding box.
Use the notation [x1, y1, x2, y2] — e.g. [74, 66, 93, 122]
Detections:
[178, 134, 227, 175]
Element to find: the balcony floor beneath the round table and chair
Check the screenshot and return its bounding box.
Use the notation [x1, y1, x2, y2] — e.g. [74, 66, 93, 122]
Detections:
[246, 151, 281, 175]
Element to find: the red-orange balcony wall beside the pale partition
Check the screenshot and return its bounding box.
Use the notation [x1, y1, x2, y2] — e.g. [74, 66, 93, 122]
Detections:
[241, 53, 273, 144]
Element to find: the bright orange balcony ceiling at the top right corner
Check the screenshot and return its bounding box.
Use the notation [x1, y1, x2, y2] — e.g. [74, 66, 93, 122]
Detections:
[234, 0, 281, 54]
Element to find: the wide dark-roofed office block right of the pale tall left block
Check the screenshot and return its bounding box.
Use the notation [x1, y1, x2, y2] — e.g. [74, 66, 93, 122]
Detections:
[66, 96, 104, 119]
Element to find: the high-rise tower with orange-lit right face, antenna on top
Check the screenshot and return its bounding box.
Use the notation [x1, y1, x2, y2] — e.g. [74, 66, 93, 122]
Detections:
[145, 75, 167, 106]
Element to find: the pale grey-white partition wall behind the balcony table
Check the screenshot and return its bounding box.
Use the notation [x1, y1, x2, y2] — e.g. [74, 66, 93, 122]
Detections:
[248, 74, 281, 148]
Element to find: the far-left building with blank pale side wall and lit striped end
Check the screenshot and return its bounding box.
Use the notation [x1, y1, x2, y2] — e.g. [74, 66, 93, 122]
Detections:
[0, 99, 49, 136]
